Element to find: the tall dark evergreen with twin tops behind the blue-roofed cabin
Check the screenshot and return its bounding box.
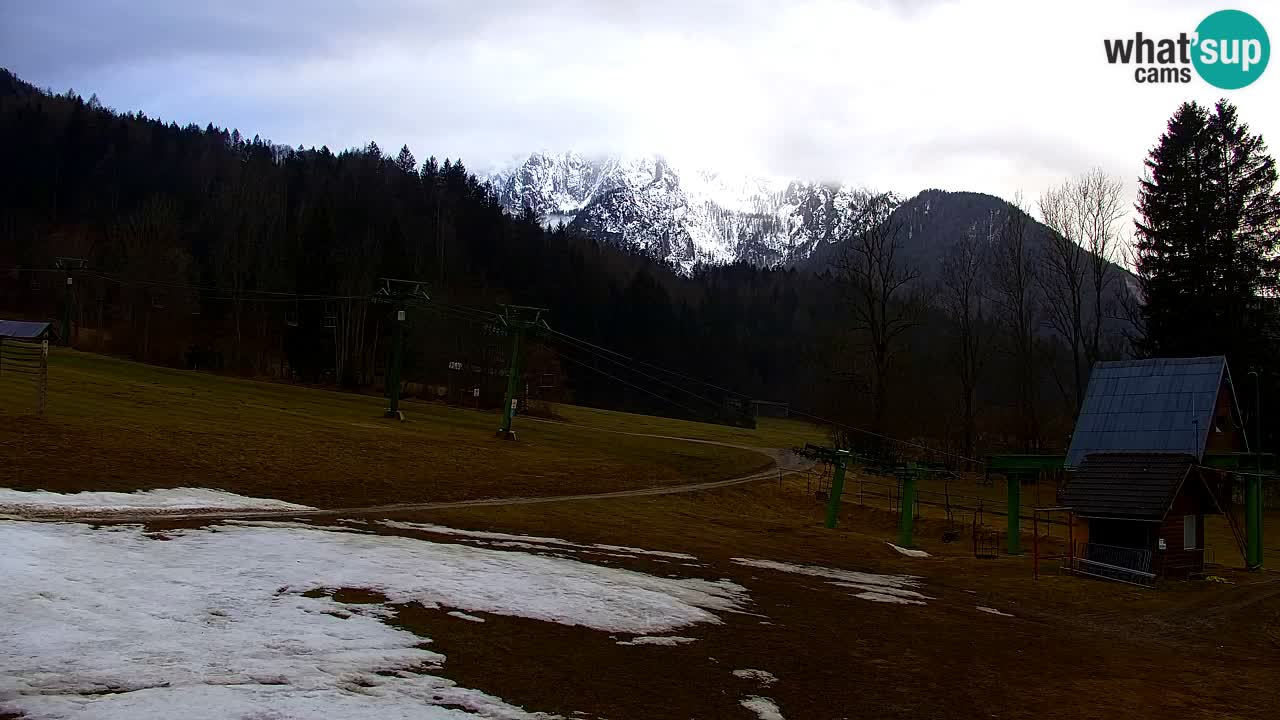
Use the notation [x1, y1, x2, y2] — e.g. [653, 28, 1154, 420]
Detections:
[1137, 100, 1280, 372]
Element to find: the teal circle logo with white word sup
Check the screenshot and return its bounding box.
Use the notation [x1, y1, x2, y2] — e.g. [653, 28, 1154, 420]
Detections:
[1192, 10, 1271, 90]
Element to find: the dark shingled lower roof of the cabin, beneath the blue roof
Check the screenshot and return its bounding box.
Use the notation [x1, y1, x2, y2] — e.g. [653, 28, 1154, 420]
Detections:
[1061, 452, 1196, 520]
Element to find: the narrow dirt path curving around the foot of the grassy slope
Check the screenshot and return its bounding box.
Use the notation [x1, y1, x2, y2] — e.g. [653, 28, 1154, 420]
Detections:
[0, 428, 813, 523]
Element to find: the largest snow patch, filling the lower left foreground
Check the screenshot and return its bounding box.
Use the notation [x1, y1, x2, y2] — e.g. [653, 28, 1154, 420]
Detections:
[0, 521, 745, 720]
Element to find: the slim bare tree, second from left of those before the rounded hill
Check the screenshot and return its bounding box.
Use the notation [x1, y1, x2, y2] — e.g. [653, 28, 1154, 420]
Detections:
[938, 220, 996, 457]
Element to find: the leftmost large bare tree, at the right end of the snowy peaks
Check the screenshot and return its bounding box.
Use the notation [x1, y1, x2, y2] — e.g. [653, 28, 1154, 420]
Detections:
[835, 191, 923, 432]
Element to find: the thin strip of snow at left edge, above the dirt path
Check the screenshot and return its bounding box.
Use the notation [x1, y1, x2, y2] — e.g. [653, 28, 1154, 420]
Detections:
[0, 488, 315, 518]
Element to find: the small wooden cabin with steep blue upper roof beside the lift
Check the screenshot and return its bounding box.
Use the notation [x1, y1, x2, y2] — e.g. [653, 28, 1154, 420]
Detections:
[1061, 356, 1248, 580]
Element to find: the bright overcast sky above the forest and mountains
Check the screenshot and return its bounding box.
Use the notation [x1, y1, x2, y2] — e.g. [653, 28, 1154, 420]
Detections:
[0, 0, 1280, 212]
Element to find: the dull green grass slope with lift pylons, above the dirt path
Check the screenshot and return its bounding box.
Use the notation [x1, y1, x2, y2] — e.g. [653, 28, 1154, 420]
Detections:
[0, 351, 820, 507]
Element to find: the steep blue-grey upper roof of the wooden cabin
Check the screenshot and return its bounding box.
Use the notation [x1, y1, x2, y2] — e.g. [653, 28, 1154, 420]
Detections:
[1066, 355, 1229, 468]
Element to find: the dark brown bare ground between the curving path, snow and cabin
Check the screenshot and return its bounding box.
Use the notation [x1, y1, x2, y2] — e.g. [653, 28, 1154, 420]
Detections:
[122, 479, 1280, 720]
